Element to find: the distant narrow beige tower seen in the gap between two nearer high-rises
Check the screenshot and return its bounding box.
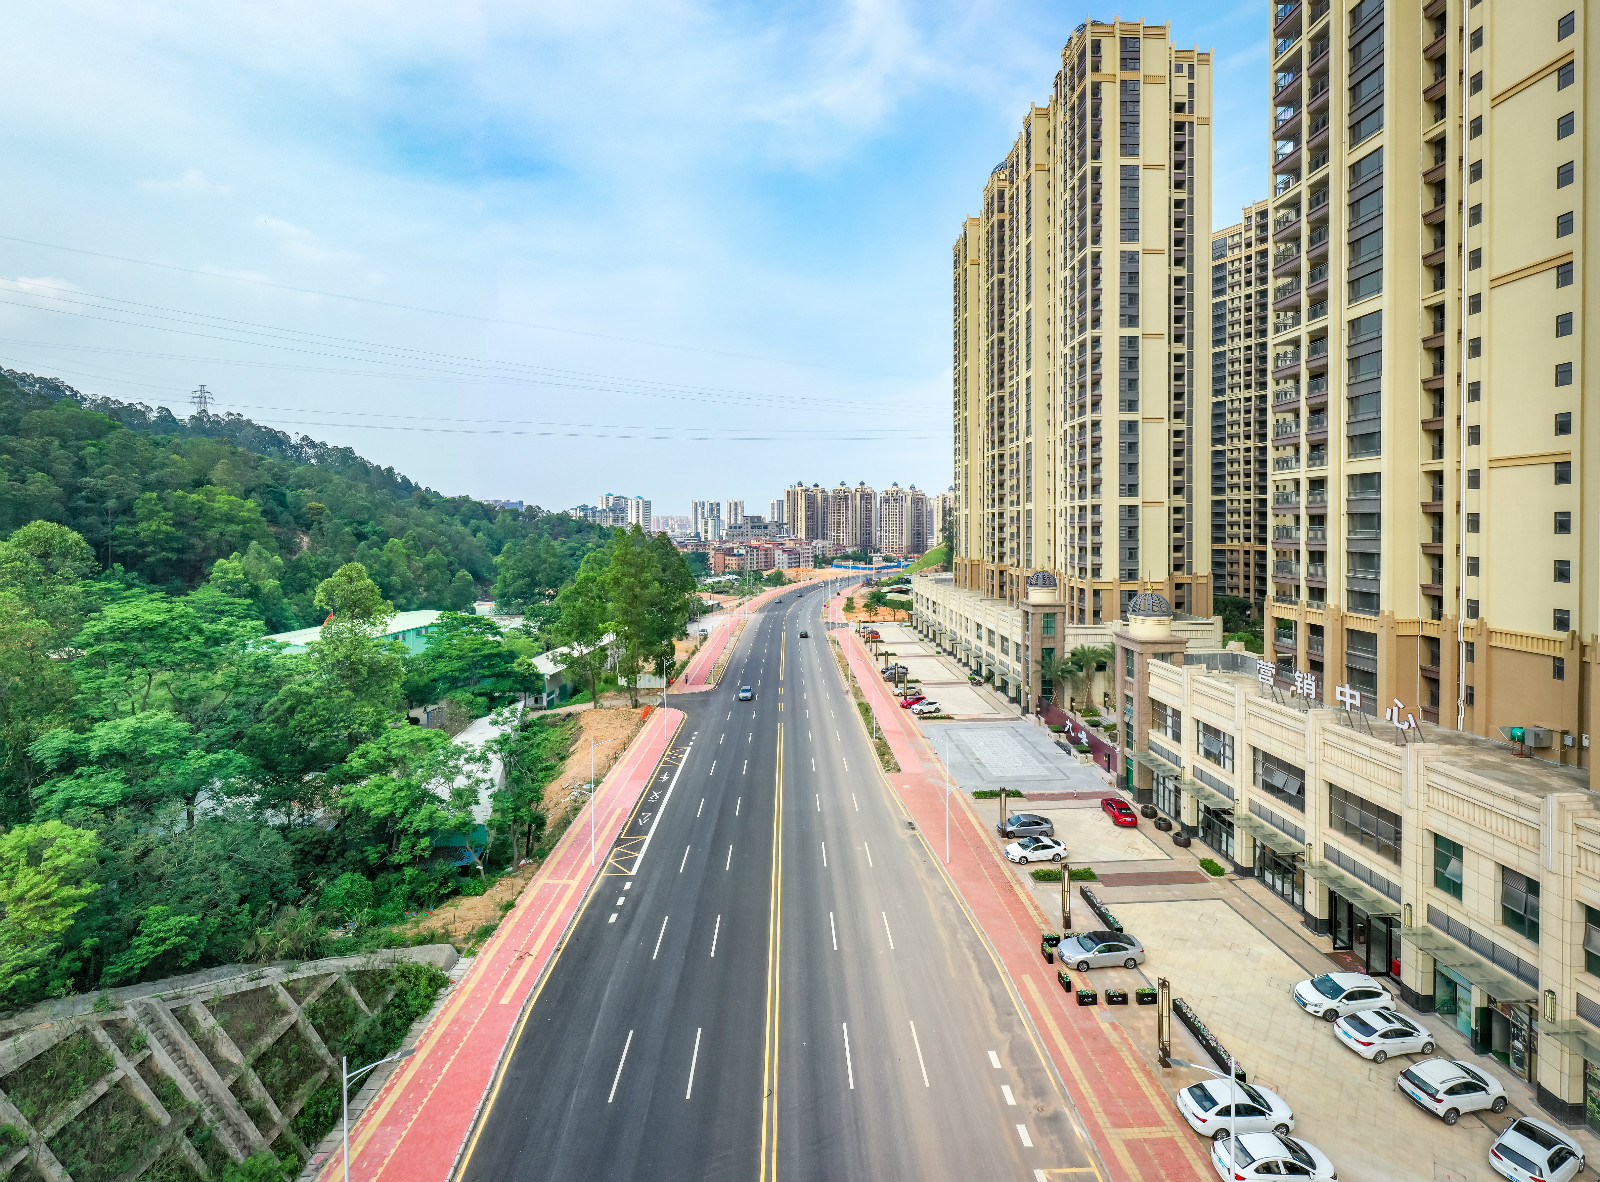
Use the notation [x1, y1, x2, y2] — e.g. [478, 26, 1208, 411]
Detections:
[1210, 200, 1272, 601]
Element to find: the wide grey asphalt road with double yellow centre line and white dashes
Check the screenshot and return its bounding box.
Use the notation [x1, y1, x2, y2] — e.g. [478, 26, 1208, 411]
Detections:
[459, 587, 1096, 1182]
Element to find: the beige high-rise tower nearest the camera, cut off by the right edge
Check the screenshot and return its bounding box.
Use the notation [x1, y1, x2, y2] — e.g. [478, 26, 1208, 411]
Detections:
[1269, 0, 1600, 766]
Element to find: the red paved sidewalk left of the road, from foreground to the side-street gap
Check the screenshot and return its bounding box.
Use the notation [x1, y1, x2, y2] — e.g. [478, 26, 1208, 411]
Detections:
[320, 709, 685, 1182]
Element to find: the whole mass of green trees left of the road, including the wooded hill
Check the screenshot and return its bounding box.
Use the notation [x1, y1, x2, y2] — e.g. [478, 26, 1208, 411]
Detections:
[0, 373, 698, 1009]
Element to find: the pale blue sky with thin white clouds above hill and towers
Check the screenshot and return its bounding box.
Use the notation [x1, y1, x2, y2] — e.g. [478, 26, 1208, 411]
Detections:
[0, 0, 1267, 513]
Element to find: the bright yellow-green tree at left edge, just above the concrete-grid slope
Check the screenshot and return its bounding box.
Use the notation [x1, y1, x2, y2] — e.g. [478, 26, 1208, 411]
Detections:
[0, 821, 99, 1004]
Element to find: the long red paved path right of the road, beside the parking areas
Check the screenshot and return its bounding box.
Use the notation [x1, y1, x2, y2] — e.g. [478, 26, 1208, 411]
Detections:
[829, 600, 1214, 1182]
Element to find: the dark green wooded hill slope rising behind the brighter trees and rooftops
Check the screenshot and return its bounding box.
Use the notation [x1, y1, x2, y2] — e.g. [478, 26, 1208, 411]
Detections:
[0, 369, 610, 632]
